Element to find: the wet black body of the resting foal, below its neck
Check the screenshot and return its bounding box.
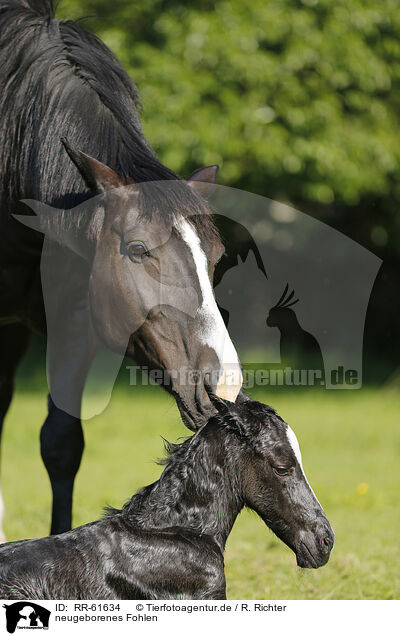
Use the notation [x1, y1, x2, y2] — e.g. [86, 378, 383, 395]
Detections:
[0, 513, 225, 600]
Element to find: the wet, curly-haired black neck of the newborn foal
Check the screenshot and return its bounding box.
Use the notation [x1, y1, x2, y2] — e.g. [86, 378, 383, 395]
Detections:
[127, 431, 243, 550]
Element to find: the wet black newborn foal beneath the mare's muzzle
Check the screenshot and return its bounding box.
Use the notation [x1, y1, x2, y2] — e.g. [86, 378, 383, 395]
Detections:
[0, 395, 334, 599]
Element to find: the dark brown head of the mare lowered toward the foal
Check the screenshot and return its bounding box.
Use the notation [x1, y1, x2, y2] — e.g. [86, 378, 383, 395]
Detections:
[64, 141, 241, 428]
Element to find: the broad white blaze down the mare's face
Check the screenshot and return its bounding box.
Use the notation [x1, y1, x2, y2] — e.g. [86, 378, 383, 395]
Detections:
[176, 219, 243, 402]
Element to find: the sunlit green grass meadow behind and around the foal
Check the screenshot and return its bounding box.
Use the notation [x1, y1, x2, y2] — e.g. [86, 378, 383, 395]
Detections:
[2, 387, 400, 599]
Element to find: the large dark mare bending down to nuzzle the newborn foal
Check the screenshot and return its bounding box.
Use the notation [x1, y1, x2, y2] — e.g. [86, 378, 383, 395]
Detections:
[0, 0, 241, 533]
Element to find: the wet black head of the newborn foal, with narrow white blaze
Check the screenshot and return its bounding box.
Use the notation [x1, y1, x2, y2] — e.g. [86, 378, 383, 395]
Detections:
[211, 394, 334, 568]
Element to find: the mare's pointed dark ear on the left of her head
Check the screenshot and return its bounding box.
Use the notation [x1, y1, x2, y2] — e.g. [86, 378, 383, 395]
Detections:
[61, 137, 126, 194]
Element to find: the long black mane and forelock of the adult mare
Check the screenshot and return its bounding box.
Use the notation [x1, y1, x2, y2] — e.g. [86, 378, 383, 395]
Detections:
[0, 0, 213, 238]
